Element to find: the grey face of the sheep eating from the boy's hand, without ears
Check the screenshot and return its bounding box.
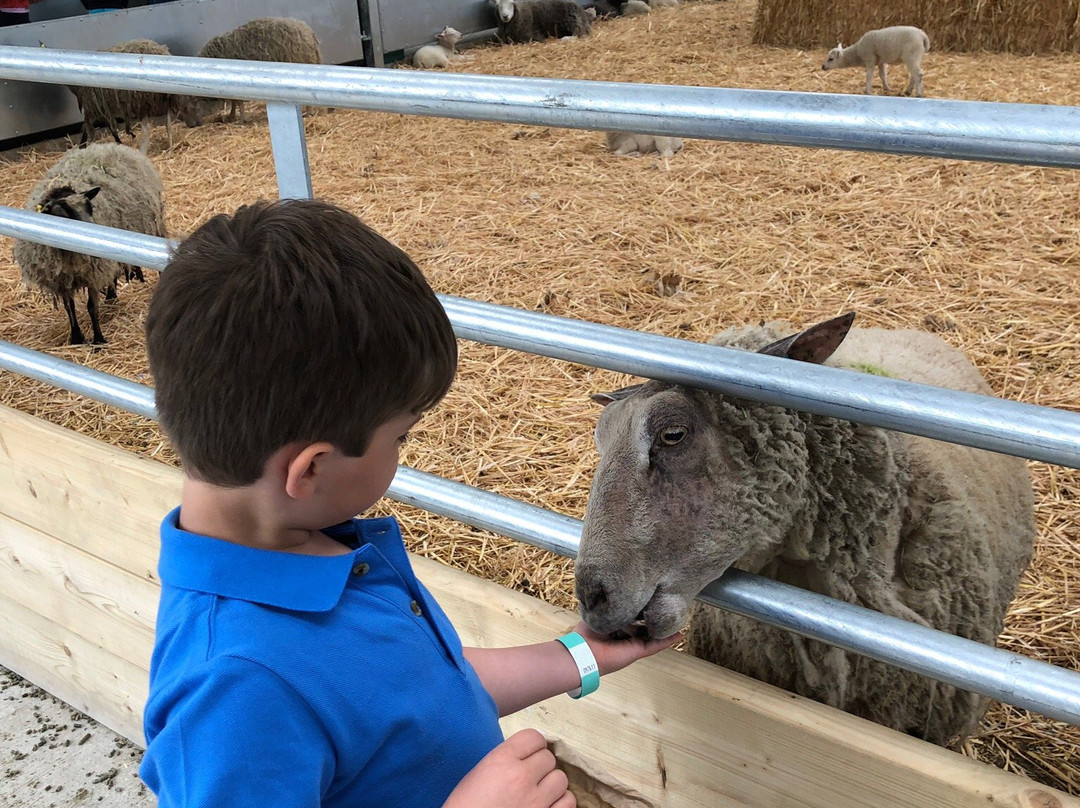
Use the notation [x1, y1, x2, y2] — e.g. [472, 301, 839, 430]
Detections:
[575, 381, 753, 637]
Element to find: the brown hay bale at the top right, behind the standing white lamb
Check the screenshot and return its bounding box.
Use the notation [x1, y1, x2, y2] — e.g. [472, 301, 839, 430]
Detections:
[752, 0, 1080, 55]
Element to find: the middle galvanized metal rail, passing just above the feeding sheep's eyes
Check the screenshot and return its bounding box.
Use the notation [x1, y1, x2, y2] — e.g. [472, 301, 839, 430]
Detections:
[0, 206, 1080, 468]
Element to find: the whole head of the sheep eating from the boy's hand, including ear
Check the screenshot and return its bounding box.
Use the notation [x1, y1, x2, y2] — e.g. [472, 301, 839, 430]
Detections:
[575, 315, 853, 637]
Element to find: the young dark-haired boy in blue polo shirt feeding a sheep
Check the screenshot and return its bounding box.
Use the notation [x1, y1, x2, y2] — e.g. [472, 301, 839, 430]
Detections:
[140, 200, 678, 808]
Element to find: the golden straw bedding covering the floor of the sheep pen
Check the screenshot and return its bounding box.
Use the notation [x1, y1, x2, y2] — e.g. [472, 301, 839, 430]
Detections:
[0, 0, 1080, 793]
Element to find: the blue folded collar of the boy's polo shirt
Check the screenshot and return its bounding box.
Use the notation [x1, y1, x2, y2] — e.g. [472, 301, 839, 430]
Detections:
[158, 508, 400, 611]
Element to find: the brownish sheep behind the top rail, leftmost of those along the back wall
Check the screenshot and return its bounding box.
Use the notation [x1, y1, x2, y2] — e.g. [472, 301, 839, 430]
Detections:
[68, 39, 200, 154]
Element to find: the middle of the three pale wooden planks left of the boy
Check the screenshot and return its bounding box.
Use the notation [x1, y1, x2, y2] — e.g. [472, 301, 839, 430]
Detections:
[0, 514, 160, 671]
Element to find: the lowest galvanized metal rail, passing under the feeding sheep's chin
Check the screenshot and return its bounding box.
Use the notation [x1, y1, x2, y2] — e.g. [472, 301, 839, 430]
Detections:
[0, 341, 1080, 725]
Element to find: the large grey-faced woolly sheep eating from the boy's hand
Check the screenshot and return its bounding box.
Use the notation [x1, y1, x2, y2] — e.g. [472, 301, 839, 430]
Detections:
[575, 313, 1036, 745]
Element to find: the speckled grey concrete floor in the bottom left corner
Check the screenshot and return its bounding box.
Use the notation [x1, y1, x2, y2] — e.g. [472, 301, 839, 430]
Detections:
[0, 668, 157, 808]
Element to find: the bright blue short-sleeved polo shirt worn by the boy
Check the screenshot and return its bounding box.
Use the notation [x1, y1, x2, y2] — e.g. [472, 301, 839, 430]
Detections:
[139, 509, 502, 808]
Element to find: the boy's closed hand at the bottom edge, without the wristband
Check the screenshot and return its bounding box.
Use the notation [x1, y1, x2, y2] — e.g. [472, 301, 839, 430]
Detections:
[443, 729, 578, 808]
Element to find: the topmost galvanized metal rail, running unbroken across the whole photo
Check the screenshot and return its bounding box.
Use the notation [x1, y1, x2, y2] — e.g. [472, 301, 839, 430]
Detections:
[0, 46, 1080, 169]
